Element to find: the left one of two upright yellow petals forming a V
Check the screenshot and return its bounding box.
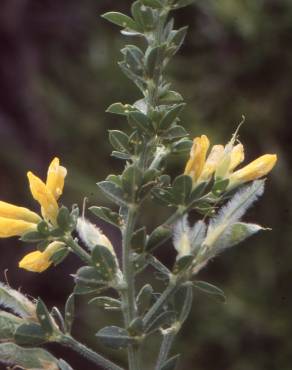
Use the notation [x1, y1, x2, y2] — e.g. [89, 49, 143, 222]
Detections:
[27, 172, 59, 223]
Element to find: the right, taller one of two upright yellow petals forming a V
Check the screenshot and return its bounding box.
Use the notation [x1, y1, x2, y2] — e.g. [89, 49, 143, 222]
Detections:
[46, 158, 67, 200]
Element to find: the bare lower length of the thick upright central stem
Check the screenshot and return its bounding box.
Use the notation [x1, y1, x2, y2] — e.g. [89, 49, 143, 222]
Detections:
[121, 206, 140, 370]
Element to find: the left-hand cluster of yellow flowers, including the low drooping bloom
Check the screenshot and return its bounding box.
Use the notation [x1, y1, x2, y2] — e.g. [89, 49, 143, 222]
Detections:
[0, 158, 67, 272]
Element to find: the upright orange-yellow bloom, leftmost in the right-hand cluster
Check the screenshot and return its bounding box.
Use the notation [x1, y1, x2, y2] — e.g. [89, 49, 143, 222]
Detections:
[184, 135, 210, 182]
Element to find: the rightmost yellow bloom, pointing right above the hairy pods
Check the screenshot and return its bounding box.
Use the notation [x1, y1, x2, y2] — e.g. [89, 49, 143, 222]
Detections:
[230, 154, 277, 186]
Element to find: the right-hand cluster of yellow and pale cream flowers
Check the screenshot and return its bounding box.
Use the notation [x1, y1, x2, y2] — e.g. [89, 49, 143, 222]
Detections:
[185, 135, 277, 190]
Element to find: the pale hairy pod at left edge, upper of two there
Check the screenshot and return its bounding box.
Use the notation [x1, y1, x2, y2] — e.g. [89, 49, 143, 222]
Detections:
[0, 283, 36, 318]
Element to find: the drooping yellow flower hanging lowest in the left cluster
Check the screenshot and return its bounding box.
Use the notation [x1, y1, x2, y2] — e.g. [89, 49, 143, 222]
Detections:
[18, 241, 65, 272]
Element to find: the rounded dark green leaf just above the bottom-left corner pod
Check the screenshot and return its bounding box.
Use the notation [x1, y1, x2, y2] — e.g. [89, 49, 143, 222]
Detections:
[14, 323, 48, 346]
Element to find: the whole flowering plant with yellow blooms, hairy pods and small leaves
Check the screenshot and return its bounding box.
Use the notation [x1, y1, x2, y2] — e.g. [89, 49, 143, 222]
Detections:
[0, 0, 277, 370]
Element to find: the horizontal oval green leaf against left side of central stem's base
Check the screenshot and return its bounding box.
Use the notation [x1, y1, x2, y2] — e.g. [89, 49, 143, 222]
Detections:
[96, 326, 135, 349]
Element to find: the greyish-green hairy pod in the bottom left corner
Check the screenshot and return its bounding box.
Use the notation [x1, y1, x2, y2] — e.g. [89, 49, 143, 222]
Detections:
[0, 343, 58, 370]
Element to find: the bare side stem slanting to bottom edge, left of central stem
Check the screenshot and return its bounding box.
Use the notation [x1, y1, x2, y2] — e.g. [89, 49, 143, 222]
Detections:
[59, 335, 123, 370]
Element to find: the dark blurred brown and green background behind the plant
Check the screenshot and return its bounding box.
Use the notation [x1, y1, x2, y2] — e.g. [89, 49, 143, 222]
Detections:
[0, 0, 292, 370]
